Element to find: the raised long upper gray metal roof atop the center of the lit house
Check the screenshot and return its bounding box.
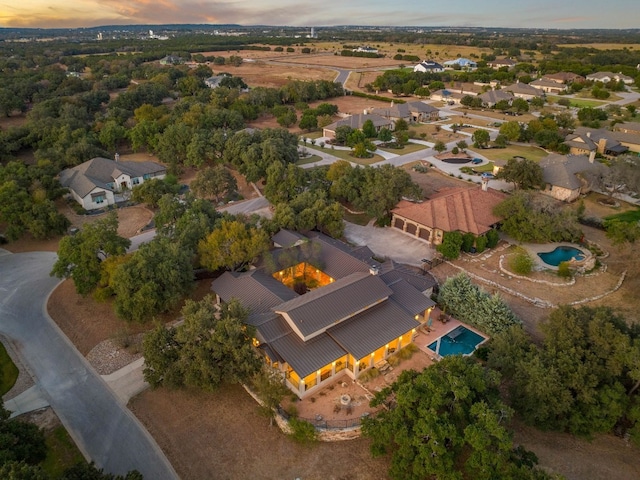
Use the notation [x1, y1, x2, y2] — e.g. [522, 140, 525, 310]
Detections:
[273, 272, 393, 338]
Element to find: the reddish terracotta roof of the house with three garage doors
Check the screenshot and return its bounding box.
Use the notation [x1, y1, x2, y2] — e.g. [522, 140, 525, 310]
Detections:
[392, 187, 506, 235]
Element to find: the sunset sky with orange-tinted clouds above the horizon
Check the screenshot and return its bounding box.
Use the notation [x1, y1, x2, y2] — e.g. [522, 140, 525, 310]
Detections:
[0, 0, 640, 29]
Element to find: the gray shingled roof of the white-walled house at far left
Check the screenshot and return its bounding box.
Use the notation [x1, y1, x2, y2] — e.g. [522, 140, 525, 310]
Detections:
[60, 157, 166, 197]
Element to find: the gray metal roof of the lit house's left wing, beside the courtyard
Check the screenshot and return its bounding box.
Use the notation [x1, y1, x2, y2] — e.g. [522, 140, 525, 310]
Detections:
[211, 270, 298, 314]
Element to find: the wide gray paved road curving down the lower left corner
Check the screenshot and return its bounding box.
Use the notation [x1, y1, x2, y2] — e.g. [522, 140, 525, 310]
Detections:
[0, 252, 178, 480]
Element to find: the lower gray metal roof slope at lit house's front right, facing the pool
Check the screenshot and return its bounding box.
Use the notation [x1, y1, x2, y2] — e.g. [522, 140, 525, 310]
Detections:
[327, 301, 420, 359]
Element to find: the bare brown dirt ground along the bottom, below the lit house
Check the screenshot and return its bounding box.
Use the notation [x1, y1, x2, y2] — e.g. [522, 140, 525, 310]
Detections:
[129, 386, 387, 480]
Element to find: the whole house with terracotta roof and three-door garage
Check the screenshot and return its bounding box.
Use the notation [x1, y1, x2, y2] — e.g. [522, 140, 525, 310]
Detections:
[391, 183, 507, 246]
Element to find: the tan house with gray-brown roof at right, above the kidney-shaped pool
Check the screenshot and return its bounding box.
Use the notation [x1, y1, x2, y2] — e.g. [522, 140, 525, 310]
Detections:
[540, 153, 607, 202]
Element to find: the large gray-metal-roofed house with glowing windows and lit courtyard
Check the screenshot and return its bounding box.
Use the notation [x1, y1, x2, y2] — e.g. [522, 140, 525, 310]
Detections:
[211, 232, 436, 398]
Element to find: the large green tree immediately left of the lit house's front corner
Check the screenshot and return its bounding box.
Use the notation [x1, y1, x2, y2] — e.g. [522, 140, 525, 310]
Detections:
[143, 295, 261, 390]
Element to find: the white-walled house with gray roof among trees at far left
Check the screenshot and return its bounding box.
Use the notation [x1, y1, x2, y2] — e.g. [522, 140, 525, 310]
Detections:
[60, 154, 167, 210]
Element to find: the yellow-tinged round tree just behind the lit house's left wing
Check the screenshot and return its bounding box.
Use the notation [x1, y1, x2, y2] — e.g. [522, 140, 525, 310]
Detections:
[198, 220, 269, 271]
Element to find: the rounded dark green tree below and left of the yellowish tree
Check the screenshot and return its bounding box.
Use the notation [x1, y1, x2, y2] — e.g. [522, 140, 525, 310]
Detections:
[111, 237, 193, 323]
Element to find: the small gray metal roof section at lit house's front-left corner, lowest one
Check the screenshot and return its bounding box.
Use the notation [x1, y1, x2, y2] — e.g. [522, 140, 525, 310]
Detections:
[270, 332, 346, 378]
